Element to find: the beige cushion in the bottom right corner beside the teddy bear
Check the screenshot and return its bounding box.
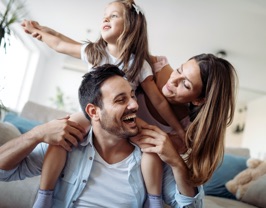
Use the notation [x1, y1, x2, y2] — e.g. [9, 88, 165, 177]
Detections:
[242, 175, 266, 207]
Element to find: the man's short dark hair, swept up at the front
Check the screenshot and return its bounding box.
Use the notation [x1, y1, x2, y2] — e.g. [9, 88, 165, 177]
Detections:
[78, 64, 125, 120]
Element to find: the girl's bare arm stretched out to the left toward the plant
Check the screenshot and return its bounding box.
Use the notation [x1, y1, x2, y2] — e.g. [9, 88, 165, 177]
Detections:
[21, 20, 81, 59]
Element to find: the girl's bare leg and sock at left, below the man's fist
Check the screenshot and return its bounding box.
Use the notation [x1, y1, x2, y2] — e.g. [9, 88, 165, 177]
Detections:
[33, 145, 67, 208]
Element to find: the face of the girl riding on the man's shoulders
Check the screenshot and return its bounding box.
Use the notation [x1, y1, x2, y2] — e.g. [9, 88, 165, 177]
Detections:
[101, 2, 124, 44]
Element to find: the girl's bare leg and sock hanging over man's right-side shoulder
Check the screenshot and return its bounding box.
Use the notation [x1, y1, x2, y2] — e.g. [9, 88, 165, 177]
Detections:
[141, 153, 163, 208]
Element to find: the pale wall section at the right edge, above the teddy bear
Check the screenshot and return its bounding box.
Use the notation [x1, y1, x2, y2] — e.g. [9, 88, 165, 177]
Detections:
[242, 96, 266, 159]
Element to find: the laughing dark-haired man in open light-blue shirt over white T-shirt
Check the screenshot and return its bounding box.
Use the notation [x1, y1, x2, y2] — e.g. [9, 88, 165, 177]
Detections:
[0, 65, 203, 208]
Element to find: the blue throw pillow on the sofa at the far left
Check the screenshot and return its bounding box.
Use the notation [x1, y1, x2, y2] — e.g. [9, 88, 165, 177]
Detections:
[4, 113, 41, 134]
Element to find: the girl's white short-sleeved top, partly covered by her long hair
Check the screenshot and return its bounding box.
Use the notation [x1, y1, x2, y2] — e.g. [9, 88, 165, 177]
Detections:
[81, 44, 153, 90]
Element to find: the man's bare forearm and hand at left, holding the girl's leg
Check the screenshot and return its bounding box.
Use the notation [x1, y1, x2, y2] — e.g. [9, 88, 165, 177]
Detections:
[0, 118, 85, 170]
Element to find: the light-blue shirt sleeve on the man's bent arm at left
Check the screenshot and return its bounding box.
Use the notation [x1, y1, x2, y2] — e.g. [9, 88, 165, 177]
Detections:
[0, 143, 48, 181]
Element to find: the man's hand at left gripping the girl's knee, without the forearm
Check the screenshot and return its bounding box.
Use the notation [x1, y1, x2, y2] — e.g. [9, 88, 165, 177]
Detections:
[32, 116, 86, 151]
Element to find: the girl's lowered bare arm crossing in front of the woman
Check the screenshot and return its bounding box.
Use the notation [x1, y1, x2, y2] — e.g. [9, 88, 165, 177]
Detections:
[141, 76, 185, 139]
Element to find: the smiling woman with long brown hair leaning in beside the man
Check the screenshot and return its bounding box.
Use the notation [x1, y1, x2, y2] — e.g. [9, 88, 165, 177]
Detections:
[133, 54, 237, 206]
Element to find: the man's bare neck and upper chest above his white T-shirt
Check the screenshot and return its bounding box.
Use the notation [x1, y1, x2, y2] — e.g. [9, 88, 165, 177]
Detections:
[93, 132, 135, 164]
